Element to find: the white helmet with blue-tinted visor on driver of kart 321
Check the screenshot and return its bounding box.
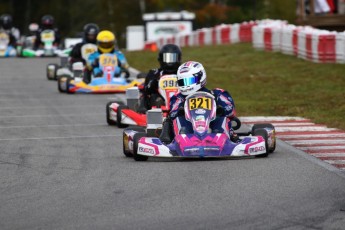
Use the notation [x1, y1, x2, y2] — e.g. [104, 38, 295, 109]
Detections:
[177, 61, 206, 96]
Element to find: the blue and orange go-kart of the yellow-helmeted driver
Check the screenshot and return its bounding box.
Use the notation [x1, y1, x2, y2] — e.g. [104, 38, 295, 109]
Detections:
[58, 53, 143, 94]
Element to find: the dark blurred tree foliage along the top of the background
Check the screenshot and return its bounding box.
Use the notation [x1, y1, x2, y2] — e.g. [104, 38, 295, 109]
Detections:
[0, 0, 295, 47]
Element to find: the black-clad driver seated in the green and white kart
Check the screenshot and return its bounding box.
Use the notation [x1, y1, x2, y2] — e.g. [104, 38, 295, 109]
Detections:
[34, 15, 61, 50]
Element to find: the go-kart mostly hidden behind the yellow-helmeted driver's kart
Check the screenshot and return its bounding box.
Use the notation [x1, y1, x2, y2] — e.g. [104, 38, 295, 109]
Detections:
[47, 43, 97, 80]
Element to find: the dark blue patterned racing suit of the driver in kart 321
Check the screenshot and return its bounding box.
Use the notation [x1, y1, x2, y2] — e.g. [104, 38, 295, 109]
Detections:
[160, 87, 238, 143]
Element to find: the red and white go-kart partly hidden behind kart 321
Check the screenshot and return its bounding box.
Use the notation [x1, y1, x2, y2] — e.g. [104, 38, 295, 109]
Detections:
[106, 75, 178, 128]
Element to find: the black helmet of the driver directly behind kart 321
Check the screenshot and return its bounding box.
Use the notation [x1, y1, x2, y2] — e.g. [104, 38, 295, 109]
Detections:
[158, 44, 182, 72]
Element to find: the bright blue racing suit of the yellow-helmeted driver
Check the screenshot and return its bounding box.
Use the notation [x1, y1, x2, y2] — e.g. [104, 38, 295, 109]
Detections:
[87, 49, 128, 76]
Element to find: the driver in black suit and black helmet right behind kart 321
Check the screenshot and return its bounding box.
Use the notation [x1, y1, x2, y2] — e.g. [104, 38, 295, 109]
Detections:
[138, 44, 182, 113]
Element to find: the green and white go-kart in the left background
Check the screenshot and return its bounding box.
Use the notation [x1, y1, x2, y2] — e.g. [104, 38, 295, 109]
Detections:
[22, 30, 71, 57]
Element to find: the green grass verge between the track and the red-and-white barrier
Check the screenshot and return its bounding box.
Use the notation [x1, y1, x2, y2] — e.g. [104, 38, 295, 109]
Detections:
[126, 43, 345, 130]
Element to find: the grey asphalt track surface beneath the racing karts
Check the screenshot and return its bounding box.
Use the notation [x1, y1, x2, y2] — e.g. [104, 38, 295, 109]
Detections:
[0, 59, 345, 230]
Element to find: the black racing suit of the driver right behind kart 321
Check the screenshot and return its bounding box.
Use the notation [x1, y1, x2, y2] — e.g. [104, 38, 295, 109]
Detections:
[138, 68, 177, 113]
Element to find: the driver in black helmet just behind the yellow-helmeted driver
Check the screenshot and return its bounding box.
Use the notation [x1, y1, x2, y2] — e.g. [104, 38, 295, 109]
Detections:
[70, 23, 99, 65]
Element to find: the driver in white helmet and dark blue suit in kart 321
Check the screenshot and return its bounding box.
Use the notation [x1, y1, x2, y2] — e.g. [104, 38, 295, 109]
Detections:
[160, 61, 238, 143]
